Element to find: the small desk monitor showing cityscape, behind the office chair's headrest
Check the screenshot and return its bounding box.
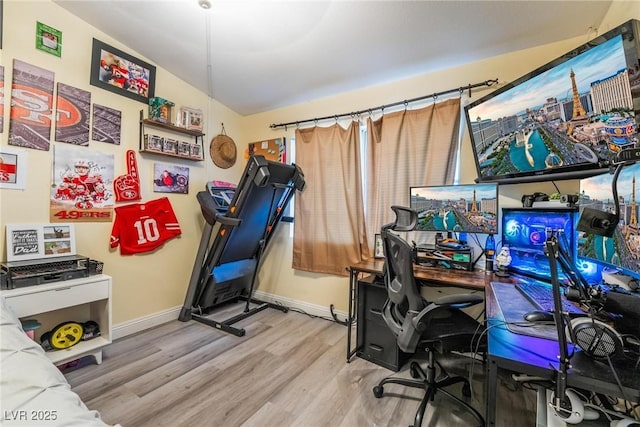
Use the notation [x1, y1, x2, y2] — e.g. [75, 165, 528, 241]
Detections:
[409, 183, 498, 234]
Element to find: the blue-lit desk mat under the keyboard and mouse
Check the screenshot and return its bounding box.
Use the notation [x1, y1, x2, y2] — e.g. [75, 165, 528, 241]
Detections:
[491, 282, 558, 341]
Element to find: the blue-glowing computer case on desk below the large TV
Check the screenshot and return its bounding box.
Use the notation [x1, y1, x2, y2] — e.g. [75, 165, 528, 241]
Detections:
[502, 208, 577, 281]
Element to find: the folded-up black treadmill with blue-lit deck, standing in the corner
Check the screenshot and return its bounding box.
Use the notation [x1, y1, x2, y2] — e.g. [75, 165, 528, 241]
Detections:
[179, 155, 305, 336]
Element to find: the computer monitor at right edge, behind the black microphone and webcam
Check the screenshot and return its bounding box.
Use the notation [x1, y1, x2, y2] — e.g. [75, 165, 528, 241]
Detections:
[577, 163, 640, 281]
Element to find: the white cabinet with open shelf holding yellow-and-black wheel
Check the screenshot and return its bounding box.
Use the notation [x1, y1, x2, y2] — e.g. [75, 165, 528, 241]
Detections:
[0, 274, 111, 365]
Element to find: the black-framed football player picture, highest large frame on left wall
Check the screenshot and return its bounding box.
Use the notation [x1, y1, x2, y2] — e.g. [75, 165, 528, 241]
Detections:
[90, 38, 156, 105]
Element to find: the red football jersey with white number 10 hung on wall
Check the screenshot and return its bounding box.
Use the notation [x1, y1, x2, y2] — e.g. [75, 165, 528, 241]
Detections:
[110, 197, 182, 255]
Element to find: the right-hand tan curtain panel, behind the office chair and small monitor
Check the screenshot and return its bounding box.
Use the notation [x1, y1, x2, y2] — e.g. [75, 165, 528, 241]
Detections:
[366, 98, 460, 251]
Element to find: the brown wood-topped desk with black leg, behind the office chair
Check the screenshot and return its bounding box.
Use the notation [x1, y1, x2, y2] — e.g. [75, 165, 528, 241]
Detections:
[347, 259, 496, 362]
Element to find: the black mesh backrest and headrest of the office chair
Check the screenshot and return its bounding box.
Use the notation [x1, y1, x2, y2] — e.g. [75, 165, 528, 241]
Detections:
[381, 206, 426, 349]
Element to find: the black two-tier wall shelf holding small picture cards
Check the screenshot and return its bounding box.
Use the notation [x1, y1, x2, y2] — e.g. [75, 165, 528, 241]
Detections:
[138, 110, 204, 162]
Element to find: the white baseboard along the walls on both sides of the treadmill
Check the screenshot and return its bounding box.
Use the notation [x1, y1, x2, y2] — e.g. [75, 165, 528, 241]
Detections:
[111, 291, 347, 340]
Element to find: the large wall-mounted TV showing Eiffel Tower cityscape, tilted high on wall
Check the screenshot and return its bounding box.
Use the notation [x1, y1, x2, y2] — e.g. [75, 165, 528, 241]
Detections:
[464, 20, 640, 183]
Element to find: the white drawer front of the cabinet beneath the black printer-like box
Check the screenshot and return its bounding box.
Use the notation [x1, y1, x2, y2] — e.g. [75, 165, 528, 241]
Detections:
[7, 280, 109, 317]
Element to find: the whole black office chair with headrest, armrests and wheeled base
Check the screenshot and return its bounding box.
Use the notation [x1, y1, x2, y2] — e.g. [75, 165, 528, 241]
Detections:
[373, 206, 484, 427]
